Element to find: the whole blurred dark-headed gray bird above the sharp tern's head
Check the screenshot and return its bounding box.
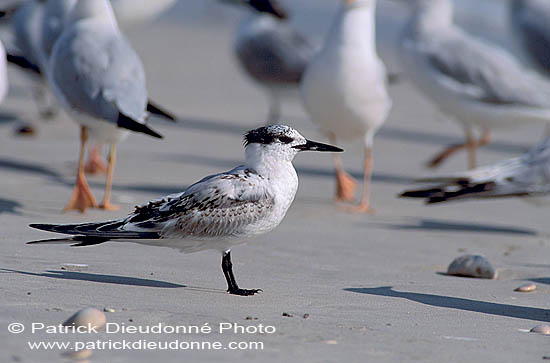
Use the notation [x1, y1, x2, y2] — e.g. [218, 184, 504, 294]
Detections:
[224, 0, 314, 124]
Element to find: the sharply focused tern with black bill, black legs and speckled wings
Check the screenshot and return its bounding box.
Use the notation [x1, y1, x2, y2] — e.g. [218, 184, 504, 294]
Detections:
[29, 125, 343, 295]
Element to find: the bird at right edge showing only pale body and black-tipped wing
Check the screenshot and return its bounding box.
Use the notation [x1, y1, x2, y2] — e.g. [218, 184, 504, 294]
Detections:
[401, 137, 550, 204]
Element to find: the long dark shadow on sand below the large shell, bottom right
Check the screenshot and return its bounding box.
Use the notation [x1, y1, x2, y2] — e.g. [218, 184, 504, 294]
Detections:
[344, 286, 550, 322]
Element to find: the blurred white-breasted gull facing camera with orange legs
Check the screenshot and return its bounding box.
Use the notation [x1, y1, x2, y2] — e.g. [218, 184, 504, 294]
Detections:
[302, 0, 391, 212]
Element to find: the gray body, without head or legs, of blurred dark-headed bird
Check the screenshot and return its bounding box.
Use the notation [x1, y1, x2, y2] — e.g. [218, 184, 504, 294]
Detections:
[235, 19, 314, 83]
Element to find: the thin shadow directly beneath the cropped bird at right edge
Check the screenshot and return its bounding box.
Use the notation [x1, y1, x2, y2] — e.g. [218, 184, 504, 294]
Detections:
[371, 218, 538, 236]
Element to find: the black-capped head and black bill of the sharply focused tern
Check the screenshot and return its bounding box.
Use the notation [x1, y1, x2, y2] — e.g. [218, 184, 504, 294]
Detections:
[244, 125, 344, 161]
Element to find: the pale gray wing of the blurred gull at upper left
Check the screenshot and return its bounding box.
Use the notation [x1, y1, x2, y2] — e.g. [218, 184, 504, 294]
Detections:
[50, 21, 147, 123]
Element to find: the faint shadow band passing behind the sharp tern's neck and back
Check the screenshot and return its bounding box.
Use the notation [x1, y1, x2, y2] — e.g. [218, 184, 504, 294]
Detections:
[157, 154, 413, 185]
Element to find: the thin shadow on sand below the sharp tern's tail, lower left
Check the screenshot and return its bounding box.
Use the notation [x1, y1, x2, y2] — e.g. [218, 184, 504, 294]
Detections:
[0, 268, 187, 288]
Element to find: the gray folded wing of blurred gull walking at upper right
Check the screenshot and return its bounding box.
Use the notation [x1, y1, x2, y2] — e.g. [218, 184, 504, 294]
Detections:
[412, 29, 550, 108]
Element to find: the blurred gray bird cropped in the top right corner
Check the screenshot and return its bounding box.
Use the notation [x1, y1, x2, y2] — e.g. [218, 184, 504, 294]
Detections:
[510, 0, 550, 76]
